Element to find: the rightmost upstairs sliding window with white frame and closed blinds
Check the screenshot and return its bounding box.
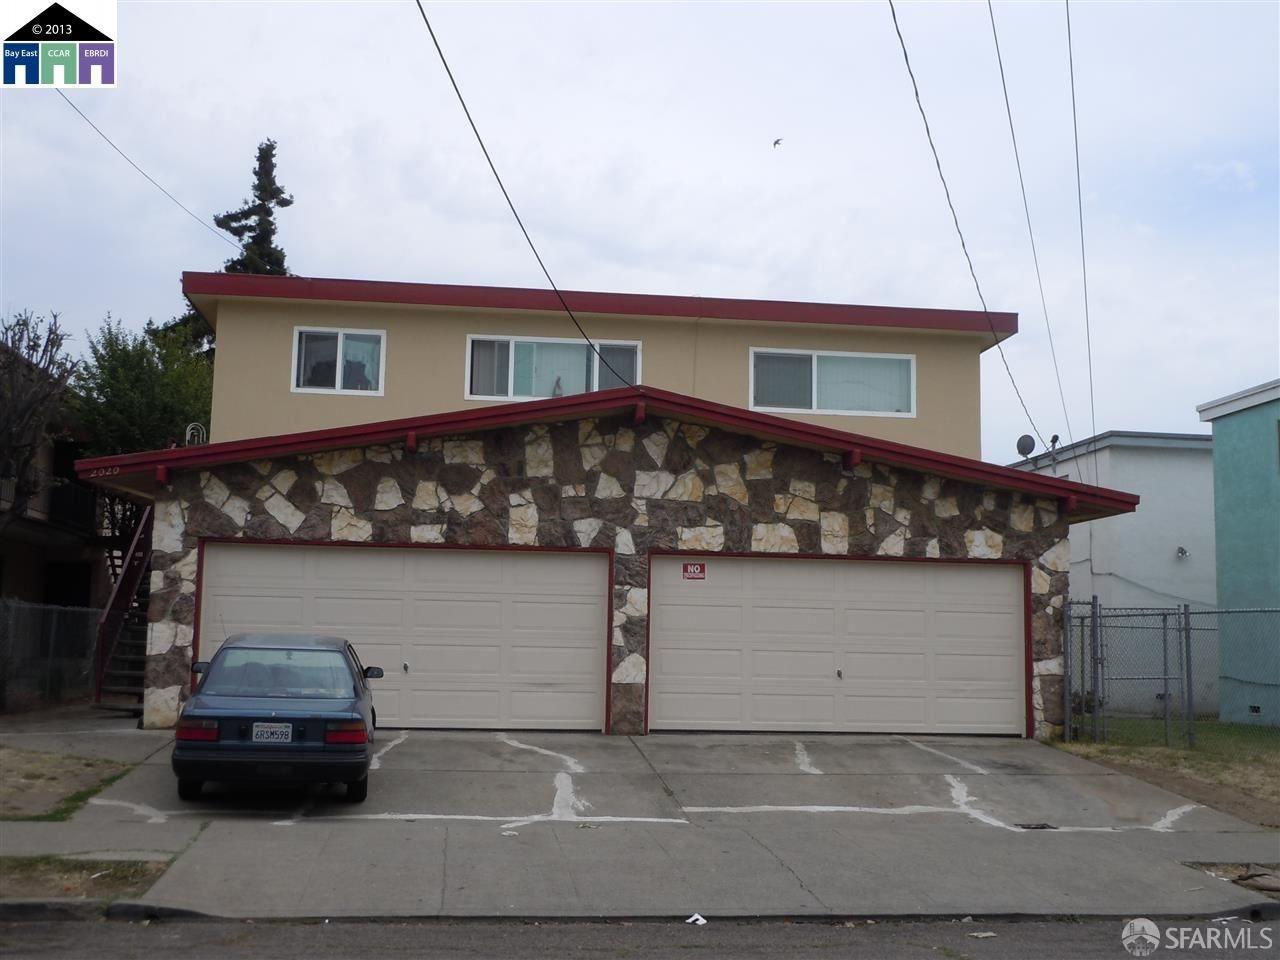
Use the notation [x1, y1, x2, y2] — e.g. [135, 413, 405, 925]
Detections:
[751, 347, 915, 417]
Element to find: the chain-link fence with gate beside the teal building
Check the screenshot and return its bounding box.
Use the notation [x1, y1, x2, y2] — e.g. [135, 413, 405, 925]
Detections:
[1064, 598, 1280, 755]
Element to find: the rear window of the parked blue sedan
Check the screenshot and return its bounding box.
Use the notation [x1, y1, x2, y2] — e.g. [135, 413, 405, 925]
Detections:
[200, 646, 356, 699]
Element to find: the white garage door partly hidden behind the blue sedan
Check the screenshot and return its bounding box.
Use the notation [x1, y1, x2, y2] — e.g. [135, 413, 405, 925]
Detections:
[200, 544, 608, 730]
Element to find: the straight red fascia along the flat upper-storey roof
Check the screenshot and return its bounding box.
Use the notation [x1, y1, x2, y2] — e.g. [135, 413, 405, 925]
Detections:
[182, 273, 1018, 335]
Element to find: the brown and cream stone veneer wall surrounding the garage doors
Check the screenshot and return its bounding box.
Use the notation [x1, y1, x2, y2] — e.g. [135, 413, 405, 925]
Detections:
[145, 417, 1070, 736]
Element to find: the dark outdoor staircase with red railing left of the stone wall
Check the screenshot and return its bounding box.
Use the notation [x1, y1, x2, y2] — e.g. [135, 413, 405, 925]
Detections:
[93, 507, 152, 716]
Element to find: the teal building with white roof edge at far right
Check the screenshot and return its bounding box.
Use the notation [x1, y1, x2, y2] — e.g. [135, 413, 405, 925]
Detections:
[1196, 380, 1280, 726]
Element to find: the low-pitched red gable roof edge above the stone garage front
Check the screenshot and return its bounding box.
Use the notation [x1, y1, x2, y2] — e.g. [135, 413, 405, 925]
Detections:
[76, 387, 1138, 524]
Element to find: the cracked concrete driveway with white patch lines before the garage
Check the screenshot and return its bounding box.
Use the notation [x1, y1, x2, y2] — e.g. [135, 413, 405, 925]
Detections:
[0, 716, 1280, 916]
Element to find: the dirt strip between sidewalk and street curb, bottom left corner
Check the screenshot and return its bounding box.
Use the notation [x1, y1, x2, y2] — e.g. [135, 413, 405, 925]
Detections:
[0, 856, 169, 900]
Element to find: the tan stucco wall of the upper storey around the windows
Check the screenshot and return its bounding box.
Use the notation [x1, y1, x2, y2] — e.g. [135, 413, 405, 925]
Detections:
[210, 301, 989, 457]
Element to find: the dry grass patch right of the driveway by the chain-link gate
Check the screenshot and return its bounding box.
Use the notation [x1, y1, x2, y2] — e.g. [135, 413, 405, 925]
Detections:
[1060, 718, 1280, 826]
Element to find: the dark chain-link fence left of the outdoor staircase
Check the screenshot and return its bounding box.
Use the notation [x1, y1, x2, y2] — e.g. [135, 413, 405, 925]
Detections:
[0, 599, 102, 713]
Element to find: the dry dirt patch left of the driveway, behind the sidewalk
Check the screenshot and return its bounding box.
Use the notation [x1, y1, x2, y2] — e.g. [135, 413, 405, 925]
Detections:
[0, 746, 132, 820]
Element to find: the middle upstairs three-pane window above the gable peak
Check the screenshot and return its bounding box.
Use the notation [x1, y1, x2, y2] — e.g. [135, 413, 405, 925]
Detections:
[466, 337, 640, 399]
